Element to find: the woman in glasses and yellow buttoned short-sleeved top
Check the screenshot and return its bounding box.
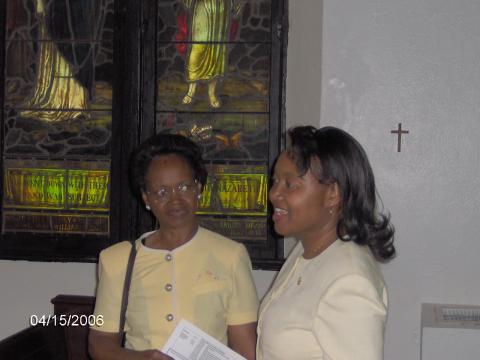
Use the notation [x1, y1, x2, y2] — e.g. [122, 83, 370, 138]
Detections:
[89, 134, 258, 359]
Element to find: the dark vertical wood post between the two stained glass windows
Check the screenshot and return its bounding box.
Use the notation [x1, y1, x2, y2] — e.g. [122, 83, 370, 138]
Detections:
[112, 0, 142, 242]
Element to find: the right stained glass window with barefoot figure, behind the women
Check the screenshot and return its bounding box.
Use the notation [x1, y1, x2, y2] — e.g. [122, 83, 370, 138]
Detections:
[151, 0, 281, 264]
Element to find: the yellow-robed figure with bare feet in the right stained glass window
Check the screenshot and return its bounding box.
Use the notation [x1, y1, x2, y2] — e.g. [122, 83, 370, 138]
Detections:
[182, 0, 241, 108]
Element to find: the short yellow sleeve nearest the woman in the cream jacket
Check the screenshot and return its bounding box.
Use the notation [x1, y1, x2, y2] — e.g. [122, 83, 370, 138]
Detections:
[227, 244, 258, 325]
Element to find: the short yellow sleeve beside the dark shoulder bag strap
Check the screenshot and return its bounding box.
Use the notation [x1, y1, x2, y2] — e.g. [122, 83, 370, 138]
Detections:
[91, 251, 126, 332]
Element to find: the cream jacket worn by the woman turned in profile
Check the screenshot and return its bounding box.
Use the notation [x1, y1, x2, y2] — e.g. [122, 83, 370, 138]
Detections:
[257, 240, 387, 360]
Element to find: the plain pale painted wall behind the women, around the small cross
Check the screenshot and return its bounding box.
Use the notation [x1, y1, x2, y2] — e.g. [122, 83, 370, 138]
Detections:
[0, 0, 480, 360]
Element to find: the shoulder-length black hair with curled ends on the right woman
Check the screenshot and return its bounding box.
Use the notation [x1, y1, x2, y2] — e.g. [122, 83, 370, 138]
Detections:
[287, 126, 395, 261]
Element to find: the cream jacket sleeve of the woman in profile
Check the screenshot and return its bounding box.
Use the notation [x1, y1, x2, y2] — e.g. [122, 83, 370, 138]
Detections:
[313, 275, 387, 360]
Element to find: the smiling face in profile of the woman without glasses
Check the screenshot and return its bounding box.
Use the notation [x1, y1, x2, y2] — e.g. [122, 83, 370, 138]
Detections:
[269, 152, 338, 241]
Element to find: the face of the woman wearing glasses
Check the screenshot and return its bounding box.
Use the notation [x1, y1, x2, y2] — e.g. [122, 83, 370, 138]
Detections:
[142, 154, 200, 229]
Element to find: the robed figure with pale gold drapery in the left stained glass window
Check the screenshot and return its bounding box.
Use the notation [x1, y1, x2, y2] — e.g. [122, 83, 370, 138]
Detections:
[21, 0, 101, 122]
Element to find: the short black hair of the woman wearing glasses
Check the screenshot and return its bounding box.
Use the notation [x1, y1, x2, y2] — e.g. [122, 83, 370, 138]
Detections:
[131, 133, 208, 194]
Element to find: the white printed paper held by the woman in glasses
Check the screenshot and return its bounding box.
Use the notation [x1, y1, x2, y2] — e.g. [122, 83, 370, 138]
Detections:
[162, 319, 246, 360]
